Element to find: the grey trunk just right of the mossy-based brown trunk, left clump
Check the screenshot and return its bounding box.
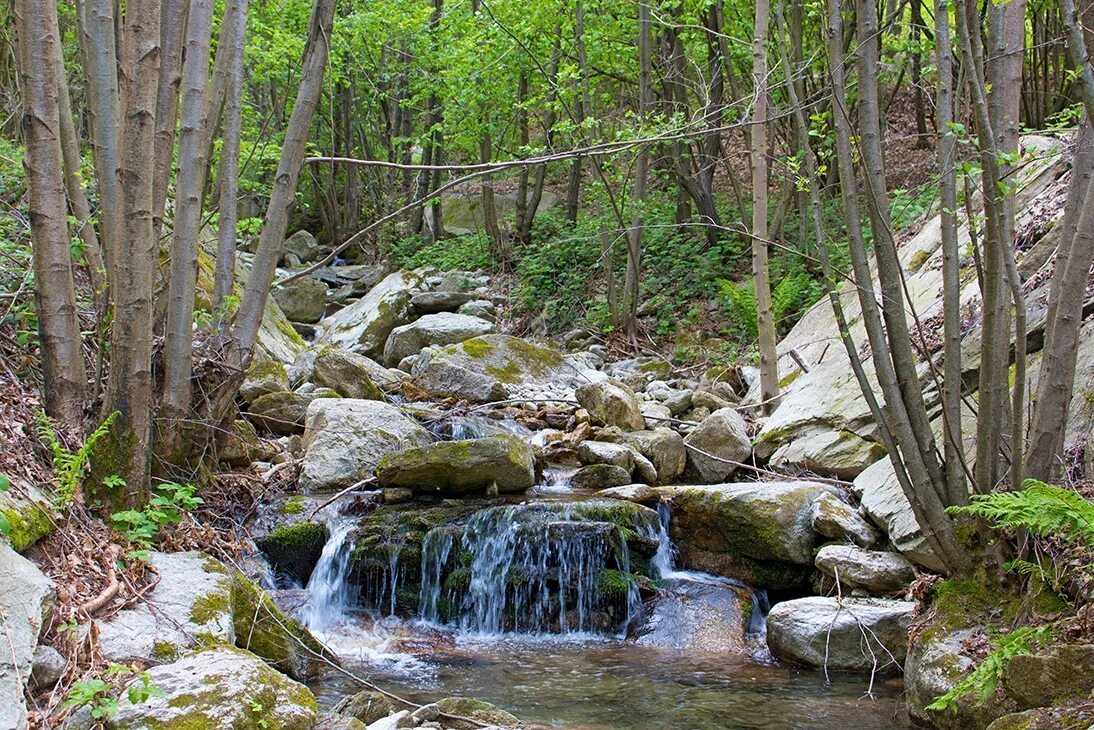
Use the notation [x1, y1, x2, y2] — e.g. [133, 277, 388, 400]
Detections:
[160, 0, 212, 450]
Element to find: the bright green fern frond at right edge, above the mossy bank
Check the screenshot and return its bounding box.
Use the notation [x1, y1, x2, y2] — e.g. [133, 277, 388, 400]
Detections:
[946, 479, 1094, 546]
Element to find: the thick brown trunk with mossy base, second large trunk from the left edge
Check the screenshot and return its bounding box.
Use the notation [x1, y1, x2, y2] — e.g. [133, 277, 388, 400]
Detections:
[104, 0, 160, 503]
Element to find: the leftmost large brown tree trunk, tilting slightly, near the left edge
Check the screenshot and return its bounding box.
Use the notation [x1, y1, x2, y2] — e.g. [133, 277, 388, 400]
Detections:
[15, 0, 88, 429]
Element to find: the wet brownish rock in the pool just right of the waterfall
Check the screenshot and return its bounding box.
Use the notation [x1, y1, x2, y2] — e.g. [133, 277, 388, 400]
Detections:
[635, 580, 753, 657]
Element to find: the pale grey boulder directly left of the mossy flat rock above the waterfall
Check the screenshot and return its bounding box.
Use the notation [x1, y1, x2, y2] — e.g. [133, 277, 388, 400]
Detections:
[300, 398, 431, 491]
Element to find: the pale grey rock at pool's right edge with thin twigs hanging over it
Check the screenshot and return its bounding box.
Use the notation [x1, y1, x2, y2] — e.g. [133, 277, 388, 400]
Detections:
[767, 596, 916, 672]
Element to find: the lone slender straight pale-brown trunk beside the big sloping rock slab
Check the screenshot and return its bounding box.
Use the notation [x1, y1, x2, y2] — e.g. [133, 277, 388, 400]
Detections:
[750, 0, 779, 413]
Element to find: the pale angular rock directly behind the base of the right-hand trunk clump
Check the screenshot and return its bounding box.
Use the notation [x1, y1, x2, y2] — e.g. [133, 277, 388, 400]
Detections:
[852, 459, 945, 572]
